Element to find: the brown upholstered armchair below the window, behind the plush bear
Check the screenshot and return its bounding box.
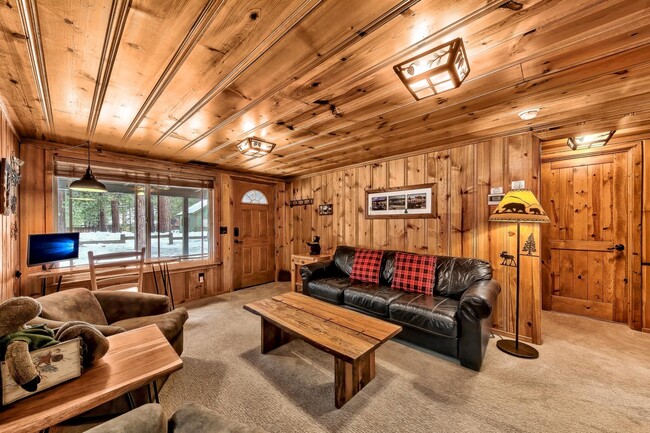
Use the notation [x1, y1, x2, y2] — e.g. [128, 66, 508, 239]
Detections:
[30, 289, 188, 355]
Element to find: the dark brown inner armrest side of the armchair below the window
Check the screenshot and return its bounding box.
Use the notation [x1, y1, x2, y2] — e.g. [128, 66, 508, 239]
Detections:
[92, 290, 170, 323]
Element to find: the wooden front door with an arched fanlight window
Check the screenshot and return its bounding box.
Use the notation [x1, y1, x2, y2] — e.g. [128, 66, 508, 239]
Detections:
[233, 181, 275, 289]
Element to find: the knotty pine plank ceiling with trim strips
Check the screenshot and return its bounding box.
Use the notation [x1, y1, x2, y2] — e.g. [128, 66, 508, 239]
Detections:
[0, 0, 650, 177]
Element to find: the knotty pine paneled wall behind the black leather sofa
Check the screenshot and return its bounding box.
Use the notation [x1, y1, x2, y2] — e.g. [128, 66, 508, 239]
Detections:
[283, 134, 541, 343]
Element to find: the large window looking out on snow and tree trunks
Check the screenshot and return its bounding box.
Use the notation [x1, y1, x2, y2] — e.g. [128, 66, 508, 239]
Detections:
[55, 176, 212, 265]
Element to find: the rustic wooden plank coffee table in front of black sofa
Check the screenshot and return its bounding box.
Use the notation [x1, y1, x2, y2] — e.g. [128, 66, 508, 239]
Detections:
[244, 292, 402, 408]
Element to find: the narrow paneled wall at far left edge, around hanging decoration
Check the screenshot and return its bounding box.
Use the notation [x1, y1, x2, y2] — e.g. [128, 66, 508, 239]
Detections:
[0, 107, 19, 302]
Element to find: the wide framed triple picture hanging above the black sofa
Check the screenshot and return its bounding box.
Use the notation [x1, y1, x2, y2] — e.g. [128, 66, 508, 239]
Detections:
[366, 183, 437, 219]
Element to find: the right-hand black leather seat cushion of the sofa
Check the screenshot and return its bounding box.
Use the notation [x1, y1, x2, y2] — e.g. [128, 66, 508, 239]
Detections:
[389, 293, 459, 338]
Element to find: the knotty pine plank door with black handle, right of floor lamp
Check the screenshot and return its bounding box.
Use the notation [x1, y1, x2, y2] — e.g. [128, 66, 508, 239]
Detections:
[542, 146, 640, 322]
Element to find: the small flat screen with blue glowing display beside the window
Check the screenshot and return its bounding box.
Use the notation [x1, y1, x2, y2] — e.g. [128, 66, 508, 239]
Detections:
[27, 233, 79, 266]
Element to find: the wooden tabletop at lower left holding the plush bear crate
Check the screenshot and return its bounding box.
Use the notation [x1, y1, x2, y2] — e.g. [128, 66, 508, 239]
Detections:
[0, 325, 183, 433]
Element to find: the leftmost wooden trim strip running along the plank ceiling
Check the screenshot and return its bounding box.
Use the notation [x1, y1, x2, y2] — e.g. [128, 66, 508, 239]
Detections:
[17, 0, 55, 134]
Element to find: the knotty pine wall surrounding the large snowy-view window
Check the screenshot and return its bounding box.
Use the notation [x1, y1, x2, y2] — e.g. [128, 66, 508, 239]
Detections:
[17, 141, 285, 303]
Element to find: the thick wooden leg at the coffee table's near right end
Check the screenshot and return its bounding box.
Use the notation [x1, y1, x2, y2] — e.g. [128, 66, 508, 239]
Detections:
[334, 351, 375, 409]
